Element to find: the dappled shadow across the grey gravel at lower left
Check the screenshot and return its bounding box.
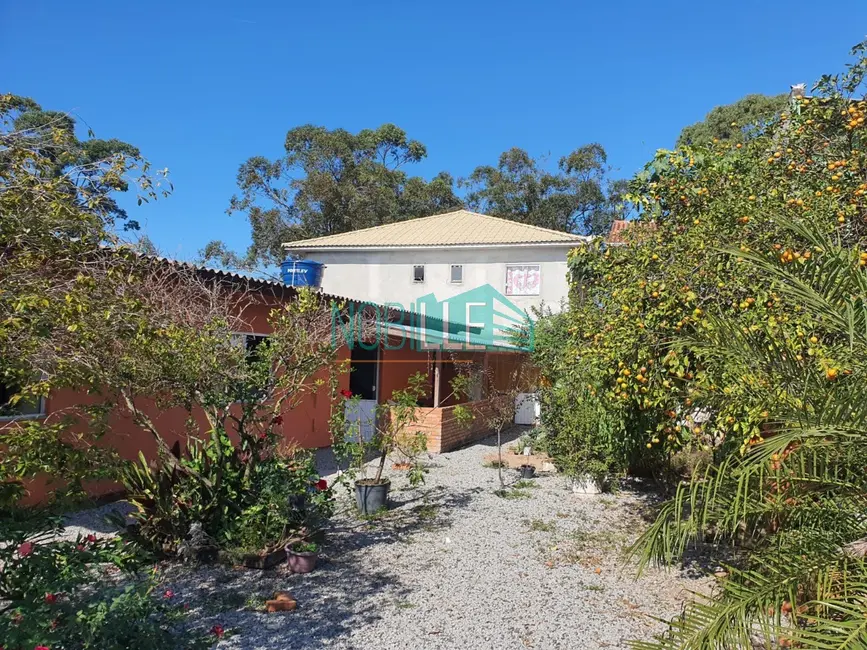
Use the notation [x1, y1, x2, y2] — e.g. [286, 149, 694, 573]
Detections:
[171, 486, 483, 650]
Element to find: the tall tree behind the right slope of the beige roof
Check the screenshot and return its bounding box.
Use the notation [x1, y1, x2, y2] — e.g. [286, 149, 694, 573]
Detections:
[459, 143, 625, 234]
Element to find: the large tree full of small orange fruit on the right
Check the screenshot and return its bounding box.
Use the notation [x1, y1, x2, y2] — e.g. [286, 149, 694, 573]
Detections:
[549, 45, 867, 470]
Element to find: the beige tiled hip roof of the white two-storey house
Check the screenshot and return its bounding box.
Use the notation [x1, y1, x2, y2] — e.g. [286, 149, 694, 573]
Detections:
[283, 210, 587, 251]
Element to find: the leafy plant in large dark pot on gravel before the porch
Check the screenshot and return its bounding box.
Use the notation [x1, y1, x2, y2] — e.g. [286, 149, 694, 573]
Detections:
[331, 373, 428, 516]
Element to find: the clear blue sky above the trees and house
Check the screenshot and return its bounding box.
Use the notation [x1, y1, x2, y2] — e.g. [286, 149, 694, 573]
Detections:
[0, 0, 867, 259]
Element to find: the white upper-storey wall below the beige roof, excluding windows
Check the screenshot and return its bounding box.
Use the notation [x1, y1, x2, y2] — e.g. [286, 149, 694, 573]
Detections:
[294, 245, 569, 311]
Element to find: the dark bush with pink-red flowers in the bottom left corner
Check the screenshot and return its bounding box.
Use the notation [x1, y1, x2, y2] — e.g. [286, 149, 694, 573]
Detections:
[0, 511, 209, 650]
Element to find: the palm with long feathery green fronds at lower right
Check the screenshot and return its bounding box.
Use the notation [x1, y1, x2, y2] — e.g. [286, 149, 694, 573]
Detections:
[634, 222, 867, 649]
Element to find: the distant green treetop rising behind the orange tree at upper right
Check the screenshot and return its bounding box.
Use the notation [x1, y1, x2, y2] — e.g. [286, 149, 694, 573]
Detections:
[677, 94, 789, 147]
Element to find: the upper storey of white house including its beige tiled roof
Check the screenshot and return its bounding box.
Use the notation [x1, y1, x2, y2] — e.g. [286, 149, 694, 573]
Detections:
[284, 210, 587, 311]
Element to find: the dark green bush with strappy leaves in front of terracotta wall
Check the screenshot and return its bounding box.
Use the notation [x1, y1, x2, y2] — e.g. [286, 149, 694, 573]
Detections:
[124, 431, 332, 554]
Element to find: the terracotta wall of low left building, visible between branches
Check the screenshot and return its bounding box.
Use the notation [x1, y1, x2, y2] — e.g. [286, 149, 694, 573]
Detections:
[0, 292, 349, 503]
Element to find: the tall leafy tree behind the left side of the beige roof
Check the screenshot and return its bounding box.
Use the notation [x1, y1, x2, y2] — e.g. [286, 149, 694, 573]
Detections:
[202, 124, 462, 266]
